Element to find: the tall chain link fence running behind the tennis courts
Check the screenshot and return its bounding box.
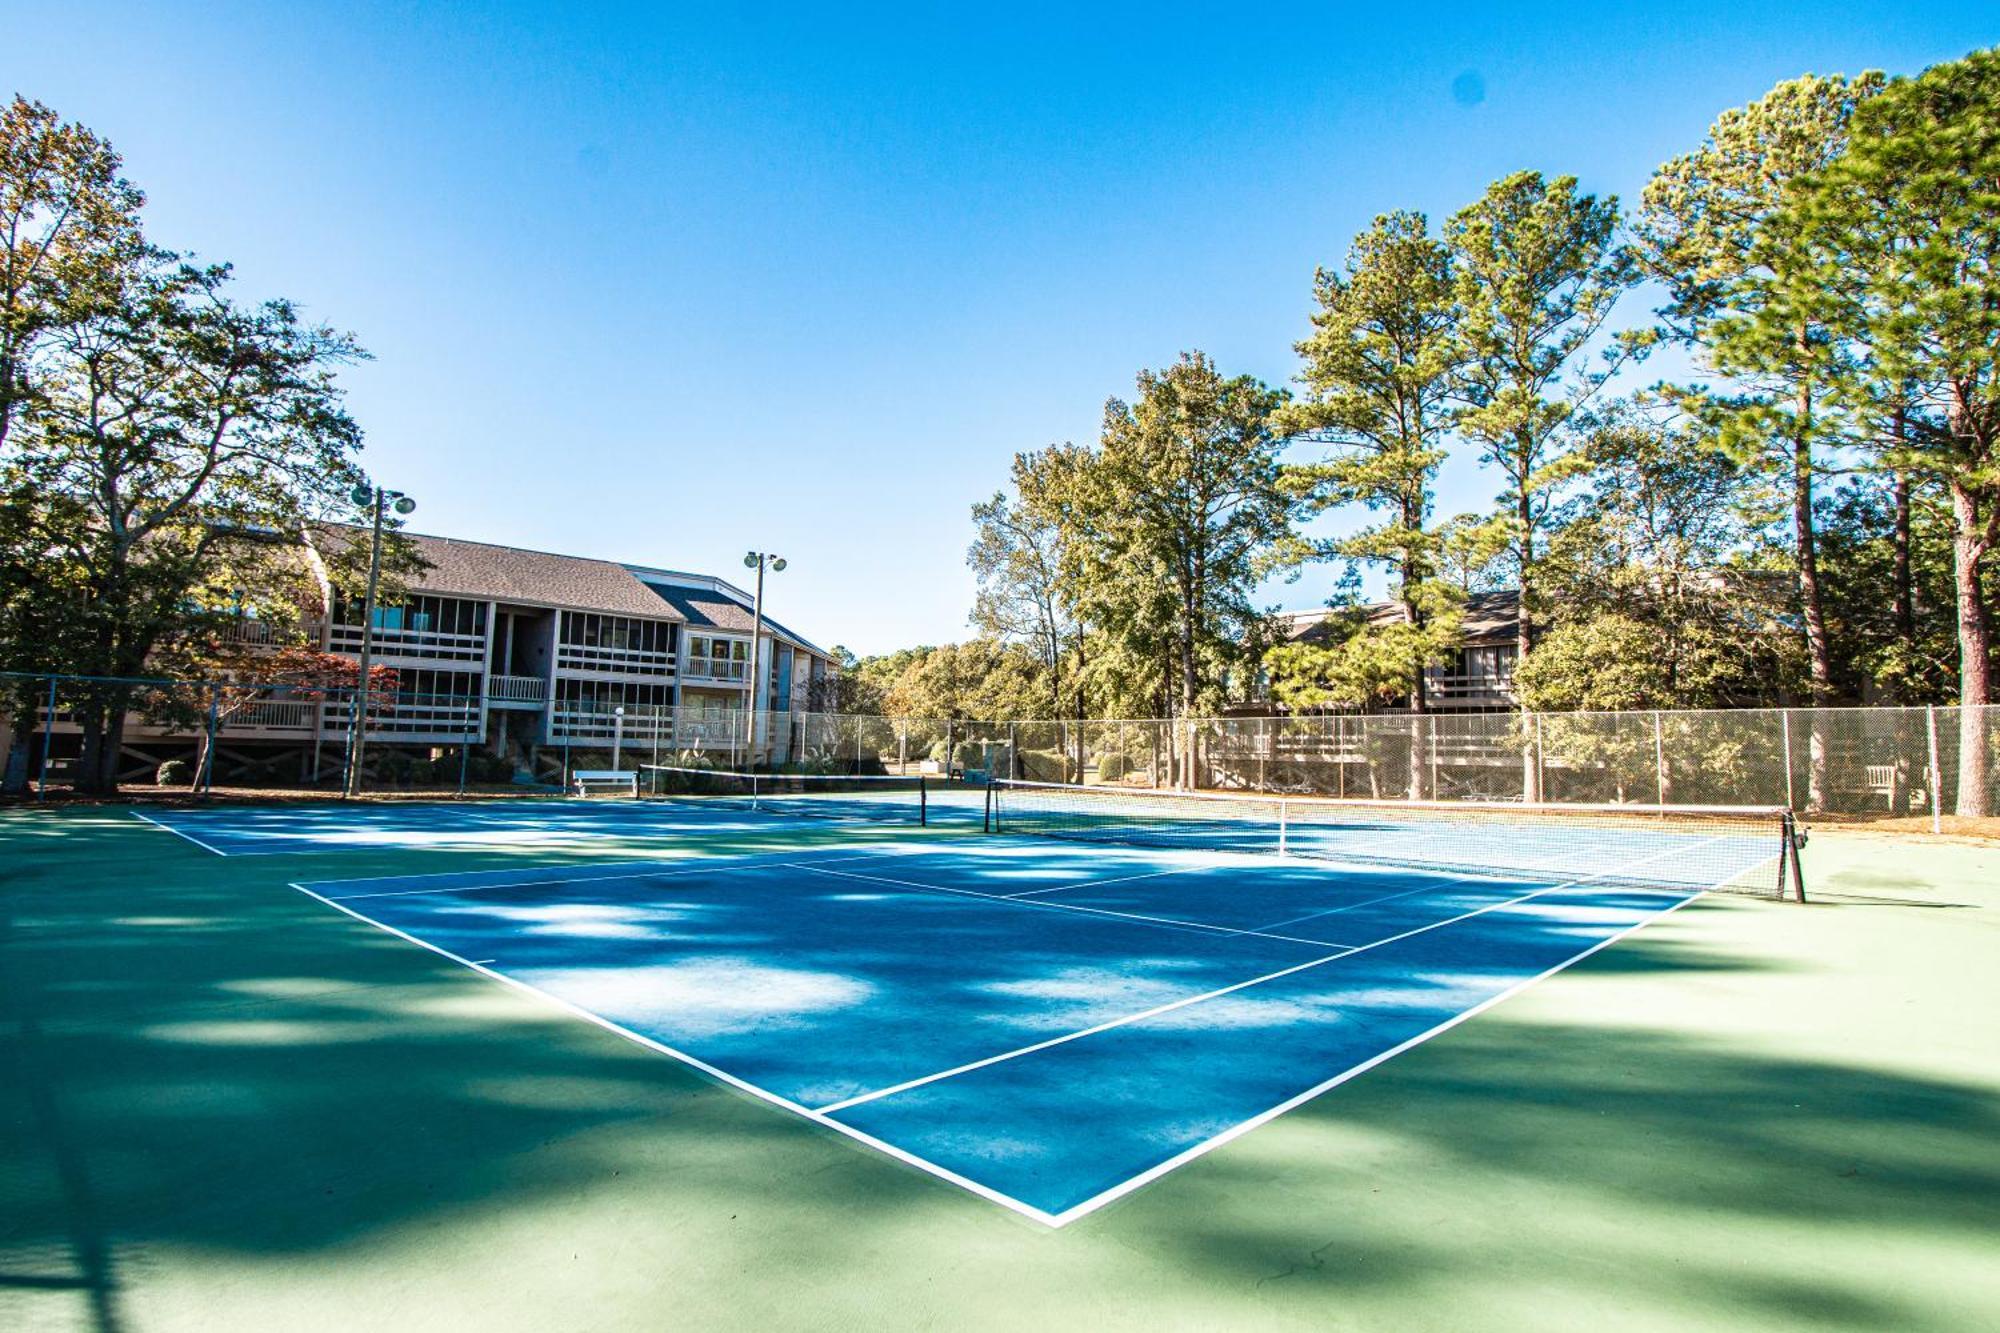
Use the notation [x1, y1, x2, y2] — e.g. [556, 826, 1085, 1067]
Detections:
[0, 675, 2000, 823]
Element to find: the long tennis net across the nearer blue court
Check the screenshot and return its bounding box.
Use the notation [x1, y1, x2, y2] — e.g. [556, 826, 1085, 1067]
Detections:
[986, 779, 1806, 901]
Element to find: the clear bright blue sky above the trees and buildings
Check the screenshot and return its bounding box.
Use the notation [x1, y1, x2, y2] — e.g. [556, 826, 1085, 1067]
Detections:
[0, 0, 2000, 652]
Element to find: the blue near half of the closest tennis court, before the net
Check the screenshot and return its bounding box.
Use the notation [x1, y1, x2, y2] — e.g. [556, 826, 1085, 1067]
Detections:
[286, 832, 1768, 1225]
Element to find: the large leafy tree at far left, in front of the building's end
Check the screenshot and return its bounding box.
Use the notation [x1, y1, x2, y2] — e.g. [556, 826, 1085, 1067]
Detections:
[0, 100, 362, 791]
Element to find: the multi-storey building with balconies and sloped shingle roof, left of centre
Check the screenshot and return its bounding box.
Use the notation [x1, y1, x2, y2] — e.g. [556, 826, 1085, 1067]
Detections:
[0, 528, 836, 783]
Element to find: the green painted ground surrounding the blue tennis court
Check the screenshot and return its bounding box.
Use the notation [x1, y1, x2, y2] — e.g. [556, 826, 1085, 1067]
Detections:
[0, 804, 2000, 1329]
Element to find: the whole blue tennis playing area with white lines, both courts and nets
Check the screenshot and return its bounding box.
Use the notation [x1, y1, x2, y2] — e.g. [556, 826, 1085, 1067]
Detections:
[250, 779, 1784, 1225]
